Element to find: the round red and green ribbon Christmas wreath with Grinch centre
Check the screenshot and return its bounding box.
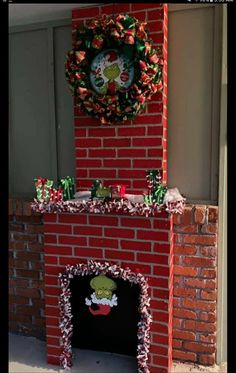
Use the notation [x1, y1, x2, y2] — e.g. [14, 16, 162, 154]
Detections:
[65, 14, 163, 124]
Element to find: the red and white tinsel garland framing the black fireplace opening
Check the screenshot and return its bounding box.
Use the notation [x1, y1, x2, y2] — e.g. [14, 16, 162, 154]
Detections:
[59, 260, 152, 373]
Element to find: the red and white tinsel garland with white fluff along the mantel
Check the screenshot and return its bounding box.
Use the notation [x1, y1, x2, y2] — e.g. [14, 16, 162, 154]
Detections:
[31, 188, 186, 217]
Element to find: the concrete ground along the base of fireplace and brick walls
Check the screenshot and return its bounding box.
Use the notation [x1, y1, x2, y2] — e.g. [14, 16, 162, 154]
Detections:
[9, 334, 227, 373]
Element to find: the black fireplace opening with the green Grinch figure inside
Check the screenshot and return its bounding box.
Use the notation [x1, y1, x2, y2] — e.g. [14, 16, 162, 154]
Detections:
[70, 275, 140, 356]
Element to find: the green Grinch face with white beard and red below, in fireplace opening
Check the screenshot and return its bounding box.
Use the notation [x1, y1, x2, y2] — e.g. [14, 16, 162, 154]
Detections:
[85, 275, 117, 315]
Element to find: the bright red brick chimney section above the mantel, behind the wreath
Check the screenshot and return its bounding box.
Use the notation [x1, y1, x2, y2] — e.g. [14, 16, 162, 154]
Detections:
[72, 3, 168, 193]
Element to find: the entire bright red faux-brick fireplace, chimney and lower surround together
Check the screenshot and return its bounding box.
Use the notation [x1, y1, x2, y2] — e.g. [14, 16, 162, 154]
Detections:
[44, 3, 173, 373]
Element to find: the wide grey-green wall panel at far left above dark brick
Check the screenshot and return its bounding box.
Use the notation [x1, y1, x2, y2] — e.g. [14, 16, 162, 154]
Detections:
[9, 30, 52, 196]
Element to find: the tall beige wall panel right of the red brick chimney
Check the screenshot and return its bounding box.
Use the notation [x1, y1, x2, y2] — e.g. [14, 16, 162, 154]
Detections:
[168, 4, 221, 203]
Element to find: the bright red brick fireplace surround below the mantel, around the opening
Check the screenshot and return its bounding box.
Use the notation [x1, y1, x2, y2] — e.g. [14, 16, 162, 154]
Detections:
[44, 213, 173, 372]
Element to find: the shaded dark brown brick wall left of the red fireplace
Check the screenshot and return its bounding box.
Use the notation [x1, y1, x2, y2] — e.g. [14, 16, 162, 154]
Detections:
[9, 199, 45, 339]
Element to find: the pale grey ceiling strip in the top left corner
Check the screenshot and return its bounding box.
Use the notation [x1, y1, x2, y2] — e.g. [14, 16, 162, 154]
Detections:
[8, 3, 98, 26]
